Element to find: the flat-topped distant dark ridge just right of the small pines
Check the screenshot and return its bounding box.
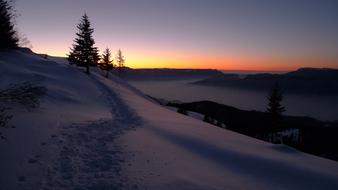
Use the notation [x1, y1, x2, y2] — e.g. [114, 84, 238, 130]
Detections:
[125, 68, 222, 81]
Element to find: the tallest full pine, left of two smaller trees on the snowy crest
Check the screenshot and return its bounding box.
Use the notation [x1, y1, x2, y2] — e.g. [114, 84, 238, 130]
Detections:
[68, 14, 100, 74]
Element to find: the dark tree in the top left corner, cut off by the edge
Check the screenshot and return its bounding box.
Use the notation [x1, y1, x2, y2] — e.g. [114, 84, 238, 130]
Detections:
[0, 0, 19, 49]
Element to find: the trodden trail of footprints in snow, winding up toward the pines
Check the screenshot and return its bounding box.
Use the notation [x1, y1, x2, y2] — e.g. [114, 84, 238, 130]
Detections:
[41, 75, 141, 190]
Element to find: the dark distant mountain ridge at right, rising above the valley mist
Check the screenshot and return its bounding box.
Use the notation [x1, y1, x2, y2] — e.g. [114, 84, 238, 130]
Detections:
[191, 68, 338, 94]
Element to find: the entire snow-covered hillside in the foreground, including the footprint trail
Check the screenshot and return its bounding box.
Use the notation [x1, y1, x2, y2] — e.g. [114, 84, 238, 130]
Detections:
[0, 50, 338, 190]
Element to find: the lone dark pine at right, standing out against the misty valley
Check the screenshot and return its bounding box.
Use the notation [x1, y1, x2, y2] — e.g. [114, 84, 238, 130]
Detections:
[267, 83, 285, 122]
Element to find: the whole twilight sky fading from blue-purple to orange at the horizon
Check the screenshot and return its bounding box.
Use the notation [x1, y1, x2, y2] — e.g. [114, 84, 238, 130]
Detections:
[15, 0, 338, 71]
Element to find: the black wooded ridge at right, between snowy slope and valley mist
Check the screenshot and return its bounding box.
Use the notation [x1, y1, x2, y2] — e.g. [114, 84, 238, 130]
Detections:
[167, 101, 338, 161]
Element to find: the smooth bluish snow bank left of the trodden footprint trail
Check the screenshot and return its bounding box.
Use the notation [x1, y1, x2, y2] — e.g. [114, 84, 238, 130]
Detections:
[0, 50, 111, 190]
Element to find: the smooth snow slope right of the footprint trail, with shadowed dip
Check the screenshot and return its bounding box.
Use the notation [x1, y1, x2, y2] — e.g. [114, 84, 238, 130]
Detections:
[107, 67, 338, 189]
